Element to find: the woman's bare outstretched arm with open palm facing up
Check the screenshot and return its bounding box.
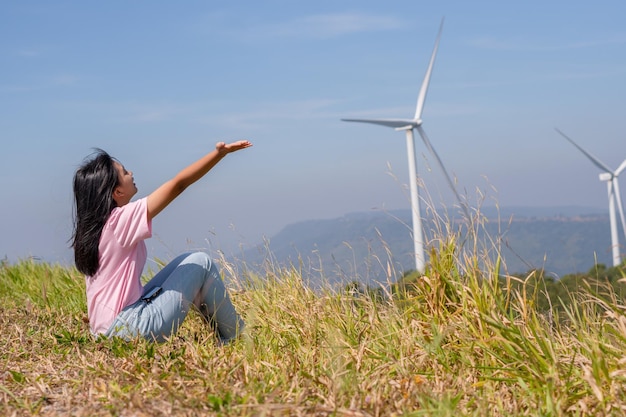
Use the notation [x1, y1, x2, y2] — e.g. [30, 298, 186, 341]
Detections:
[148, 140, 252, 219]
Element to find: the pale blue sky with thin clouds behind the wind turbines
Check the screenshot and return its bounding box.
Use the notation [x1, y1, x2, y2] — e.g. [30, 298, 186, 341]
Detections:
[0, 0, 626, 262]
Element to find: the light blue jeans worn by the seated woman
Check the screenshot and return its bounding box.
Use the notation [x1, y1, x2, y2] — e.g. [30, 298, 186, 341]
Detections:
[105, 252, 244, 343]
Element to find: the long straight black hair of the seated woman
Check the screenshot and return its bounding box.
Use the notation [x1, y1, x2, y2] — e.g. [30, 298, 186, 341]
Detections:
[72, 149, 119, 276]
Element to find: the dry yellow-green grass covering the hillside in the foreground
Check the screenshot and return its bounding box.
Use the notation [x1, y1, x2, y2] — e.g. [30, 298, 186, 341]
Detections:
[0, 234, 626, 416]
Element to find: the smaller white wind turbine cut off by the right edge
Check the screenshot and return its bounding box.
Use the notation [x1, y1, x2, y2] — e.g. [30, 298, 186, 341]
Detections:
[556, 129, 626, 266]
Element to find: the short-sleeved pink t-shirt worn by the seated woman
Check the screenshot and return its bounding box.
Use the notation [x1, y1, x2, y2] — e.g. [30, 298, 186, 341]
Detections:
[86, 198, 152, 334]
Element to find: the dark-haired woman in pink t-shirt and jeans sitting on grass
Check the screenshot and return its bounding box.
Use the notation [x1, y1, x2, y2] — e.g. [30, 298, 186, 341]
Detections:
[72, 140, 252, 343]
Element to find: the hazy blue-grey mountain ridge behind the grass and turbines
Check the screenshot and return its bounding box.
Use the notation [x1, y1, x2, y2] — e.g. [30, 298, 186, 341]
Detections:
[236, 206, 611, 285]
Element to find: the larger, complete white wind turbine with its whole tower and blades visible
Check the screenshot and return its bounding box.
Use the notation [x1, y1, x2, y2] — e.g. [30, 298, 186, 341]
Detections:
[341, 20, 470, 273]
